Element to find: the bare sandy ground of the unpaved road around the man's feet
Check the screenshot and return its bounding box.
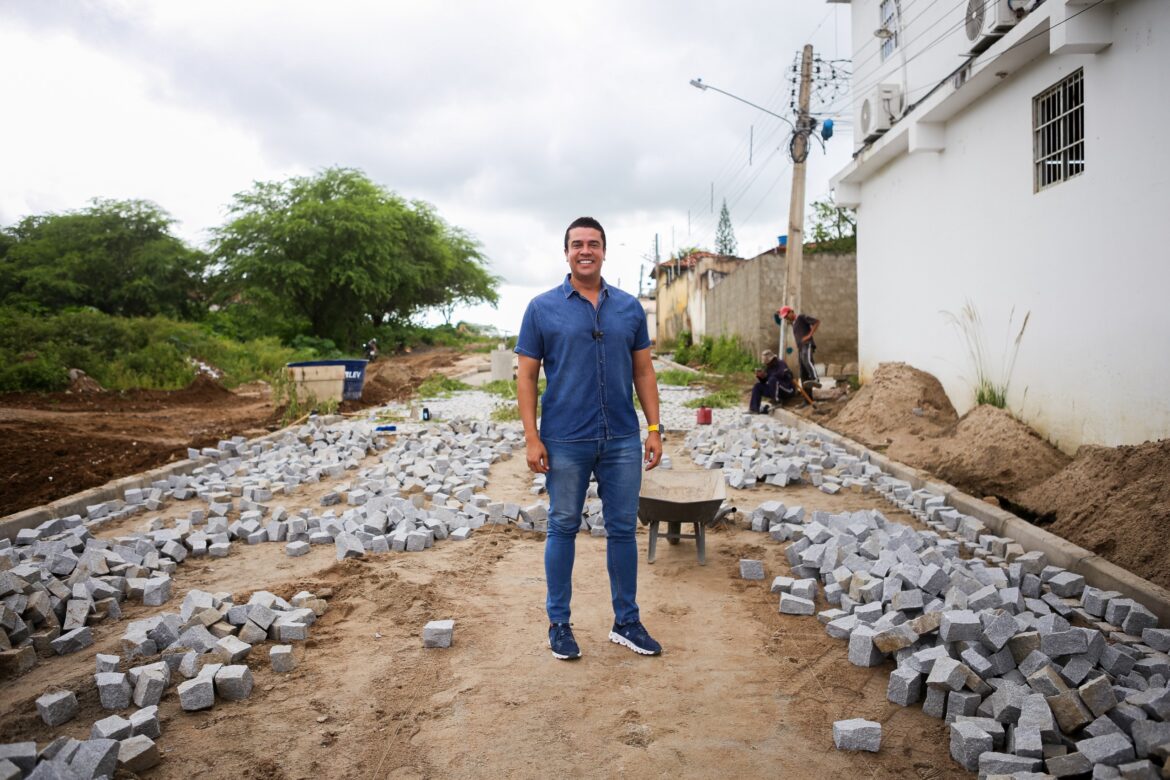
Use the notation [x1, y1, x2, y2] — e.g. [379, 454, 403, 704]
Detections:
[0, 439, 966, 779]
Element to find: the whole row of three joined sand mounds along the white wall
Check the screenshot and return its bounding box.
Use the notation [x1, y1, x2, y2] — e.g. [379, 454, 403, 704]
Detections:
[827, 363, 1170, 587]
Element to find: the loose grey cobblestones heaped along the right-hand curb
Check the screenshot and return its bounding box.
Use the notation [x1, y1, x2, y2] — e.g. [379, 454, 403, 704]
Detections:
[706, 423, 1170, 778]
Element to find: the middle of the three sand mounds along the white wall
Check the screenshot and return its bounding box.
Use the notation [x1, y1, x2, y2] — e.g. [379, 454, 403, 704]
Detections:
[912, 406, 1069, 504]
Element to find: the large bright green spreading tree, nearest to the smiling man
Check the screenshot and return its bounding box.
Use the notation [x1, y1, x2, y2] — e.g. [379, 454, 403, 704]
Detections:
[214, 168, 498, 346]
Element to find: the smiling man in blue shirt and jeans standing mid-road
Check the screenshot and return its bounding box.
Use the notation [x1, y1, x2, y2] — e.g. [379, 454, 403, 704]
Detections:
[516, 216, 662, 660]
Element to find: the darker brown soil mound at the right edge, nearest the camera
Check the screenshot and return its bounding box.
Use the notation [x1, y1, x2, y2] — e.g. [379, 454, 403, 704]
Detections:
[1019, 439, 1170, 587]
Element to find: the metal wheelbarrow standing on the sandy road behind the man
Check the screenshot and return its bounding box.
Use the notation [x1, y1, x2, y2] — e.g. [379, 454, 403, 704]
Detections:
[638, 469, 735, 566]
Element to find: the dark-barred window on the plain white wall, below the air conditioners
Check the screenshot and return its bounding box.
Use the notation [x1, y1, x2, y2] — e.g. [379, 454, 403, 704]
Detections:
[1032, 68, 1085, 192]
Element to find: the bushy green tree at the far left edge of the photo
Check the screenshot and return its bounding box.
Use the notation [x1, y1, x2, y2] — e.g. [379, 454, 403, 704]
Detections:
[0, 199, 207, 319]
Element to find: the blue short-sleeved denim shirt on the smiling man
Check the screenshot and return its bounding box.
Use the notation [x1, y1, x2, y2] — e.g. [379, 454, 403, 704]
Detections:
[516, 274, 651, 442]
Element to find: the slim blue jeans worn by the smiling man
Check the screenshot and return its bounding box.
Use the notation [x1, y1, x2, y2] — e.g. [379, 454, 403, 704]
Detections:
[544, 435, 642, 626]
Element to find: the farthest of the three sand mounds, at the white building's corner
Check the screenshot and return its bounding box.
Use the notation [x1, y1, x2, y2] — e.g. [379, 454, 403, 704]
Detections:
[831, 363, 958, 456]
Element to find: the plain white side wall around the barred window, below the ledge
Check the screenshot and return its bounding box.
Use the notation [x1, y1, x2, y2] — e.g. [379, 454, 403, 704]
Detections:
[858, 0, 1170, 451]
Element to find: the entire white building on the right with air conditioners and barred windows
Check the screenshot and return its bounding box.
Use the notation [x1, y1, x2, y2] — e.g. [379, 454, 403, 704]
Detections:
[833, 0, 1170, 451]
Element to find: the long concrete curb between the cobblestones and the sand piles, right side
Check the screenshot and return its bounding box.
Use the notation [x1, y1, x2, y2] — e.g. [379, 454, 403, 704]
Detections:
[772, 409, 1170, 627]
